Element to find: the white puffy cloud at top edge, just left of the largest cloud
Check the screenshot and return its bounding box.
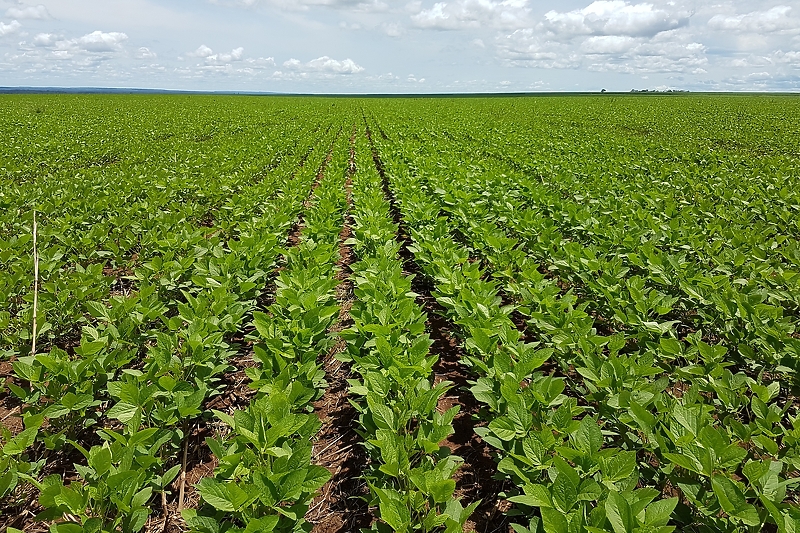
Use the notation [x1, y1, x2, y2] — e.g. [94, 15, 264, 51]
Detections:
[411, 0, 530, 30]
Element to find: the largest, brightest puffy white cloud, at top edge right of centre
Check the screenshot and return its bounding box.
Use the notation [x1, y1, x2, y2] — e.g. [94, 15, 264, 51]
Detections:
[540, 0, 691, 38]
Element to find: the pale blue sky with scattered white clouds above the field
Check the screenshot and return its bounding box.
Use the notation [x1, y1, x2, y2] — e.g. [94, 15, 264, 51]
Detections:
[0, 0, 800, 93]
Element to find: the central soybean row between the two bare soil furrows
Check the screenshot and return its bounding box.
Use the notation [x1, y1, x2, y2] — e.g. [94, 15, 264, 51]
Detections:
[339, 130, 478, 533]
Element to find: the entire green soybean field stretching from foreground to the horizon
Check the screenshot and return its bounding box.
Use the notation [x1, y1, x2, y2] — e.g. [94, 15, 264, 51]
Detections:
[0, 94, 800, 533]
